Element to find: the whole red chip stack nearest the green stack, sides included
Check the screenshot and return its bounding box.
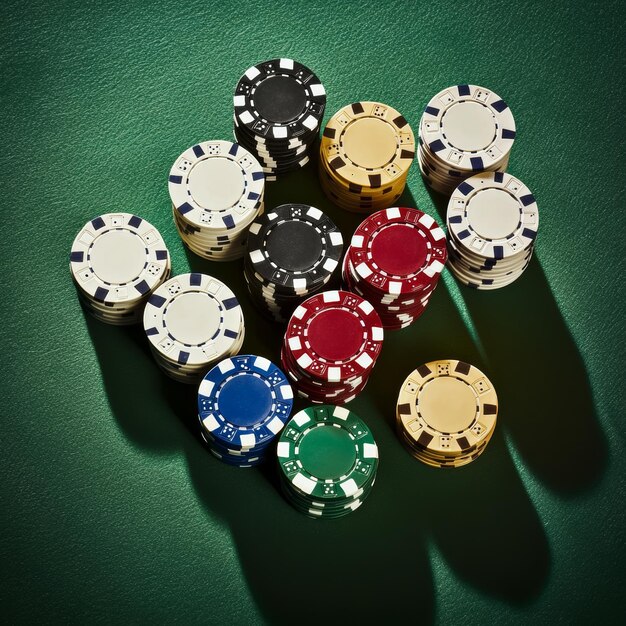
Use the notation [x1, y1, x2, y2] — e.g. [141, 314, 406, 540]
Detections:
[281, 291, 384, 404]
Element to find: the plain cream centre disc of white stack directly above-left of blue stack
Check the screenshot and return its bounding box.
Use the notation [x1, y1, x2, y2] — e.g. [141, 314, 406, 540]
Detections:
[164, 291, 221, 346]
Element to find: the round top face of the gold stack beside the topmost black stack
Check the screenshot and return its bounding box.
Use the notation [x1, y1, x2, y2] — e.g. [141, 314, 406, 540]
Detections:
[320, 102, 415, 188]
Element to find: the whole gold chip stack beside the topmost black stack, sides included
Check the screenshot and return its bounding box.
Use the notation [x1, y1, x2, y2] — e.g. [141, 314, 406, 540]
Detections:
[319, 102, 415, 213]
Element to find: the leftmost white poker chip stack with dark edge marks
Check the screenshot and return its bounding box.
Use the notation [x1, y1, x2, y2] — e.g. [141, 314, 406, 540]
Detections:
[70, 213, 171, 326]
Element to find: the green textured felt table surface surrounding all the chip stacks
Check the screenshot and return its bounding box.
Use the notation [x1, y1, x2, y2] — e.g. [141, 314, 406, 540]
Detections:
[0, 0, 626, 624]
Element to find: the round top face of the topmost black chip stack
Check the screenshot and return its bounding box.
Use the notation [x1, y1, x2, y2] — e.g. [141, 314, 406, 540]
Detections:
[234, 59, 326, 141]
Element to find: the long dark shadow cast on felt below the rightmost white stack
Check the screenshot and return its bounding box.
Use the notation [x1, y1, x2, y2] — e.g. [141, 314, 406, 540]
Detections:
[429, 183, 608, 496]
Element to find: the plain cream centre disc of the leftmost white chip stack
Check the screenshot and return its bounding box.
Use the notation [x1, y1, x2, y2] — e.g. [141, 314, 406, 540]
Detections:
[89, 230, 146, 285]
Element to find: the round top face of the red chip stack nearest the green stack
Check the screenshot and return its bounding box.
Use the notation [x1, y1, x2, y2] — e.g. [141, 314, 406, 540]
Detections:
[285, 291, 384, 382]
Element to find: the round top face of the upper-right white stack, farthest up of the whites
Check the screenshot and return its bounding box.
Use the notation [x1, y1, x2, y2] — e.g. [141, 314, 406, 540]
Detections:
[420, 85, 515, 172]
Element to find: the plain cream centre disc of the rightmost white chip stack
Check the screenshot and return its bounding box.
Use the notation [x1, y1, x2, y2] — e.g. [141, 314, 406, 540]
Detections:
[466, 188, 520, 240]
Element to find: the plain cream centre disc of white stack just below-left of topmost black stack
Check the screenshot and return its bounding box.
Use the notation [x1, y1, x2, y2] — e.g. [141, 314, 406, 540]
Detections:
[188, 157, 245, 211]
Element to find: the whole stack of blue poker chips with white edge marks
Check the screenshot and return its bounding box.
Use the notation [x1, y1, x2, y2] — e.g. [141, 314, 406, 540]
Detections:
[198, 354, 293, 467]
